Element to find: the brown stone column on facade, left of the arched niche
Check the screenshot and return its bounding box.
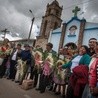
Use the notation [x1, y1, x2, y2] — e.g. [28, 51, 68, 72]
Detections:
[58, 23, 66, 51]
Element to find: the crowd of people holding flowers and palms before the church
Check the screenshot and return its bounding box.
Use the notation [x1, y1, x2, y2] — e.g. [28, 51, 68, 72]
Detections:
[0, 38, 98, 98]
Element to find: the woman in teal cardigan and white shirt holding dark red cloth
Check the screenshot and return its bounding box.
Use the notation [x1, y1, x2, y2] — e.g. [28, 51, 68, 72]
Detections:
[62, 45, 91, 98]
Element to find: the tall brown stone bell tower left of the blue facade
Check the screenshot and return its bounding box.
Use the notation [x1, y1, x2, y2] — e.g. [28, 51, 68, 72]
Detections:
[36, 0, 63, 49]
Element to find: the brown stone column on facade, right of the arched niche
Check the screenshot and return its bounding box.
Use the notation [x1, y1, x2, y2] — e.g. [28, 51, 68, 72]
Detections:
[77, 19, 86, 47]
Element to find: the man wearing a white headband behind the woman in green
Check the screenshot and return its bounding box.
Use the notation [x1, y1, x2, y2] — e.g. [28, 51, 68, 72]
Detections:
[88, 38, 97, 56]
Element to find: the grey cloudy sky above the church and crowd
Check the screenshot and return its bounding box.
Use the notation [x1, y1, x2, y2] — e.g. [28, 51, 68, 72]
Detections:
[0, 0, 98, 38]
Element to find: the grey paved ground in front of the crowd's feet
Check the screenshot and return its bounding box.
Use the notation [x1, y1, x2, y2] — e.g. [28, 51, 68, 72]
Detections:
[0, 78, 61, 98]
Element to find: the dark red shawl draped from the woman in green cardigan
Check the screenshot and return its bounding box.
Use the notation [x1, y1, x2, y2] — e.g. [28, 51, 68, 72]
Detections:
[70, 65, 89, 96]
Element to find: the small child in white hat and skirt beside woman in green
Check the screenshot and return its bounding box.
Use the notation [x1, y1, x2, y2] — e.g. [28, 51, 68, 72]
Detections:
[53, 60, 65, 96]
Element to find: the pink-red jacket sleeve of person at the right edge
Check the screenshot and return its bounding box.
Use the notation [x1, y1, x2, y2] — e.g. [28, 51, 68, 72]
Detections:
[89, 58, 98, 87]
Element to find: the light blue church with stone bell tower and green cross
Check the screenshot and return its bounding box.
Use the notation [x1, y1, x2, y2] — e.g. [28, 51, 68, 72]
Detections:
[36, 0, 98, 52]
